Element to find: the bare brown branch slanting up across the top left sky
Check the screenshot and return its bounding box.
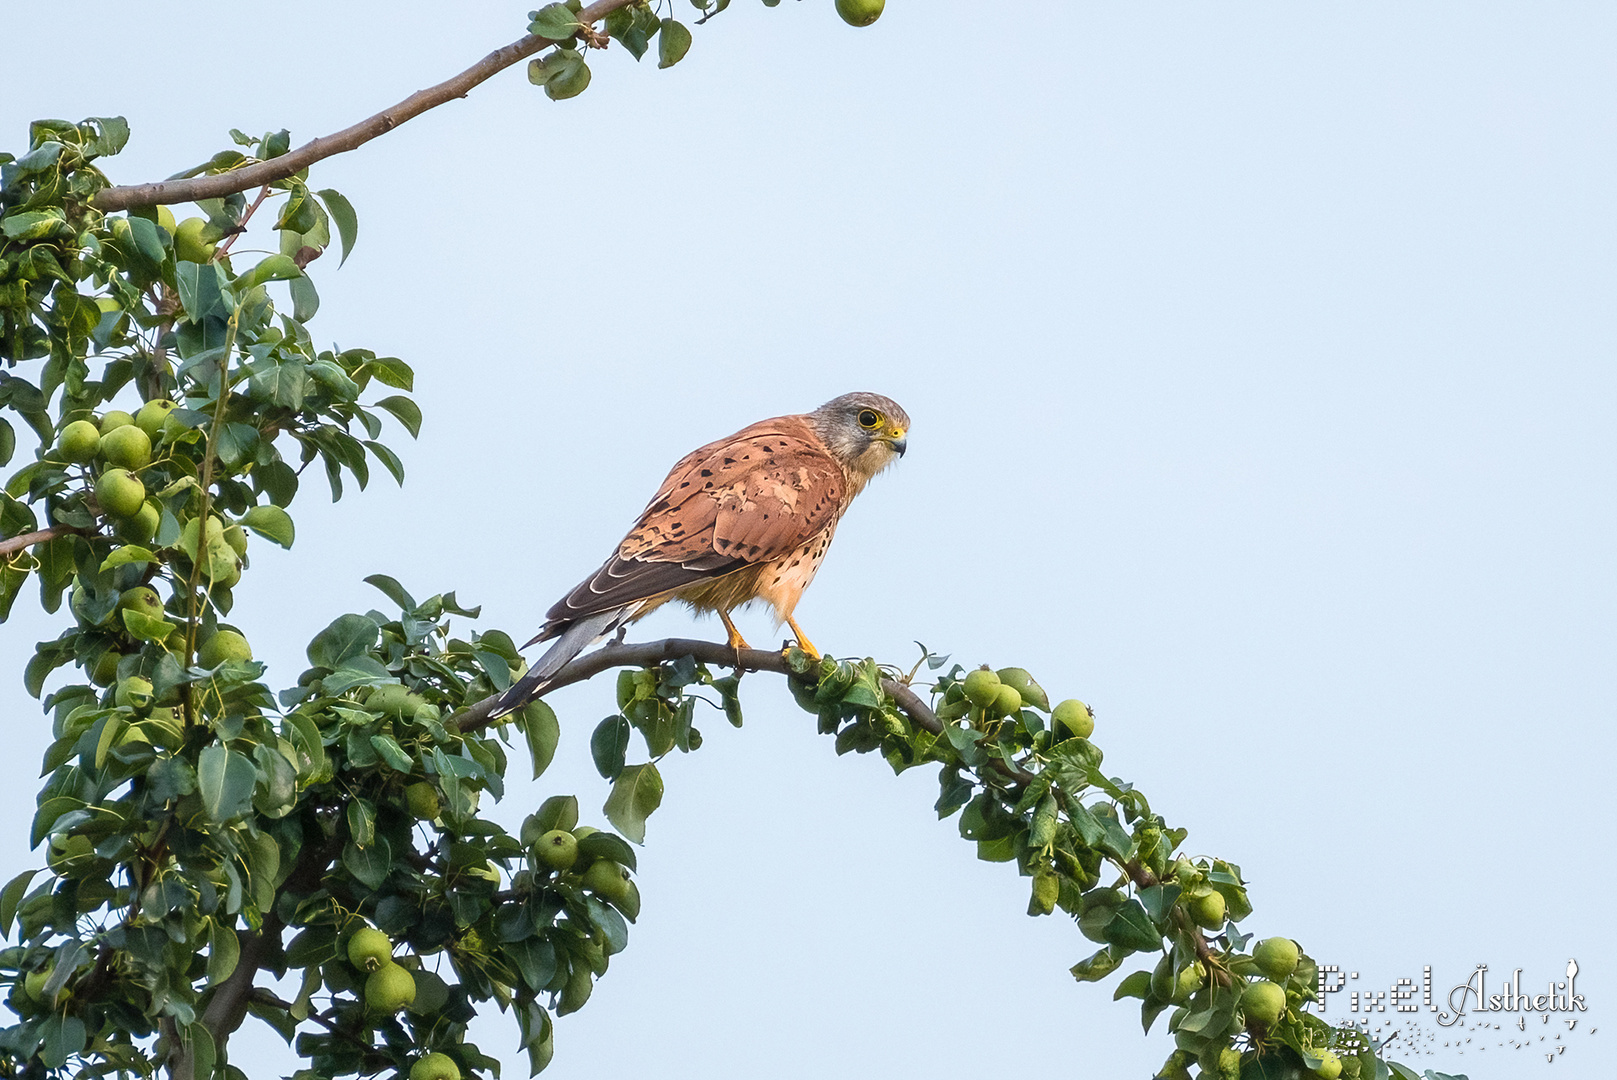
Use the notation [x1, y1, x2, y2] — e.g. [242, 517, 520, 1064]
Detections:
[92, 0, 635, 212]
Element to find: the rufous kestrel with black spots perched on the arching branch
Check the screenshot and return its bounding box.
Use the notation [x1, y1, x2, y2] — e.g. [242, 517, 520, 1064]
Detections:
[490, 393, 909, 716]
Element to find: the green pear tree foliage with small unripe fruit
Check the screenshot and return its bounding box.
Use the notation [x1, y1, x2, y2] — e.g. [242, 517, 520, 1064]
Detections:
[0, 0, 1448, 1080]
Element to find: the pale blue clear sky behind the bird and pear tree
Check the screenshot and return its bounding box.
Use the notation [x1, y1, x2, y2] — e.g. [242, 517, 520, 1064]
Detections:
[0, 0, 1617, 1080]
